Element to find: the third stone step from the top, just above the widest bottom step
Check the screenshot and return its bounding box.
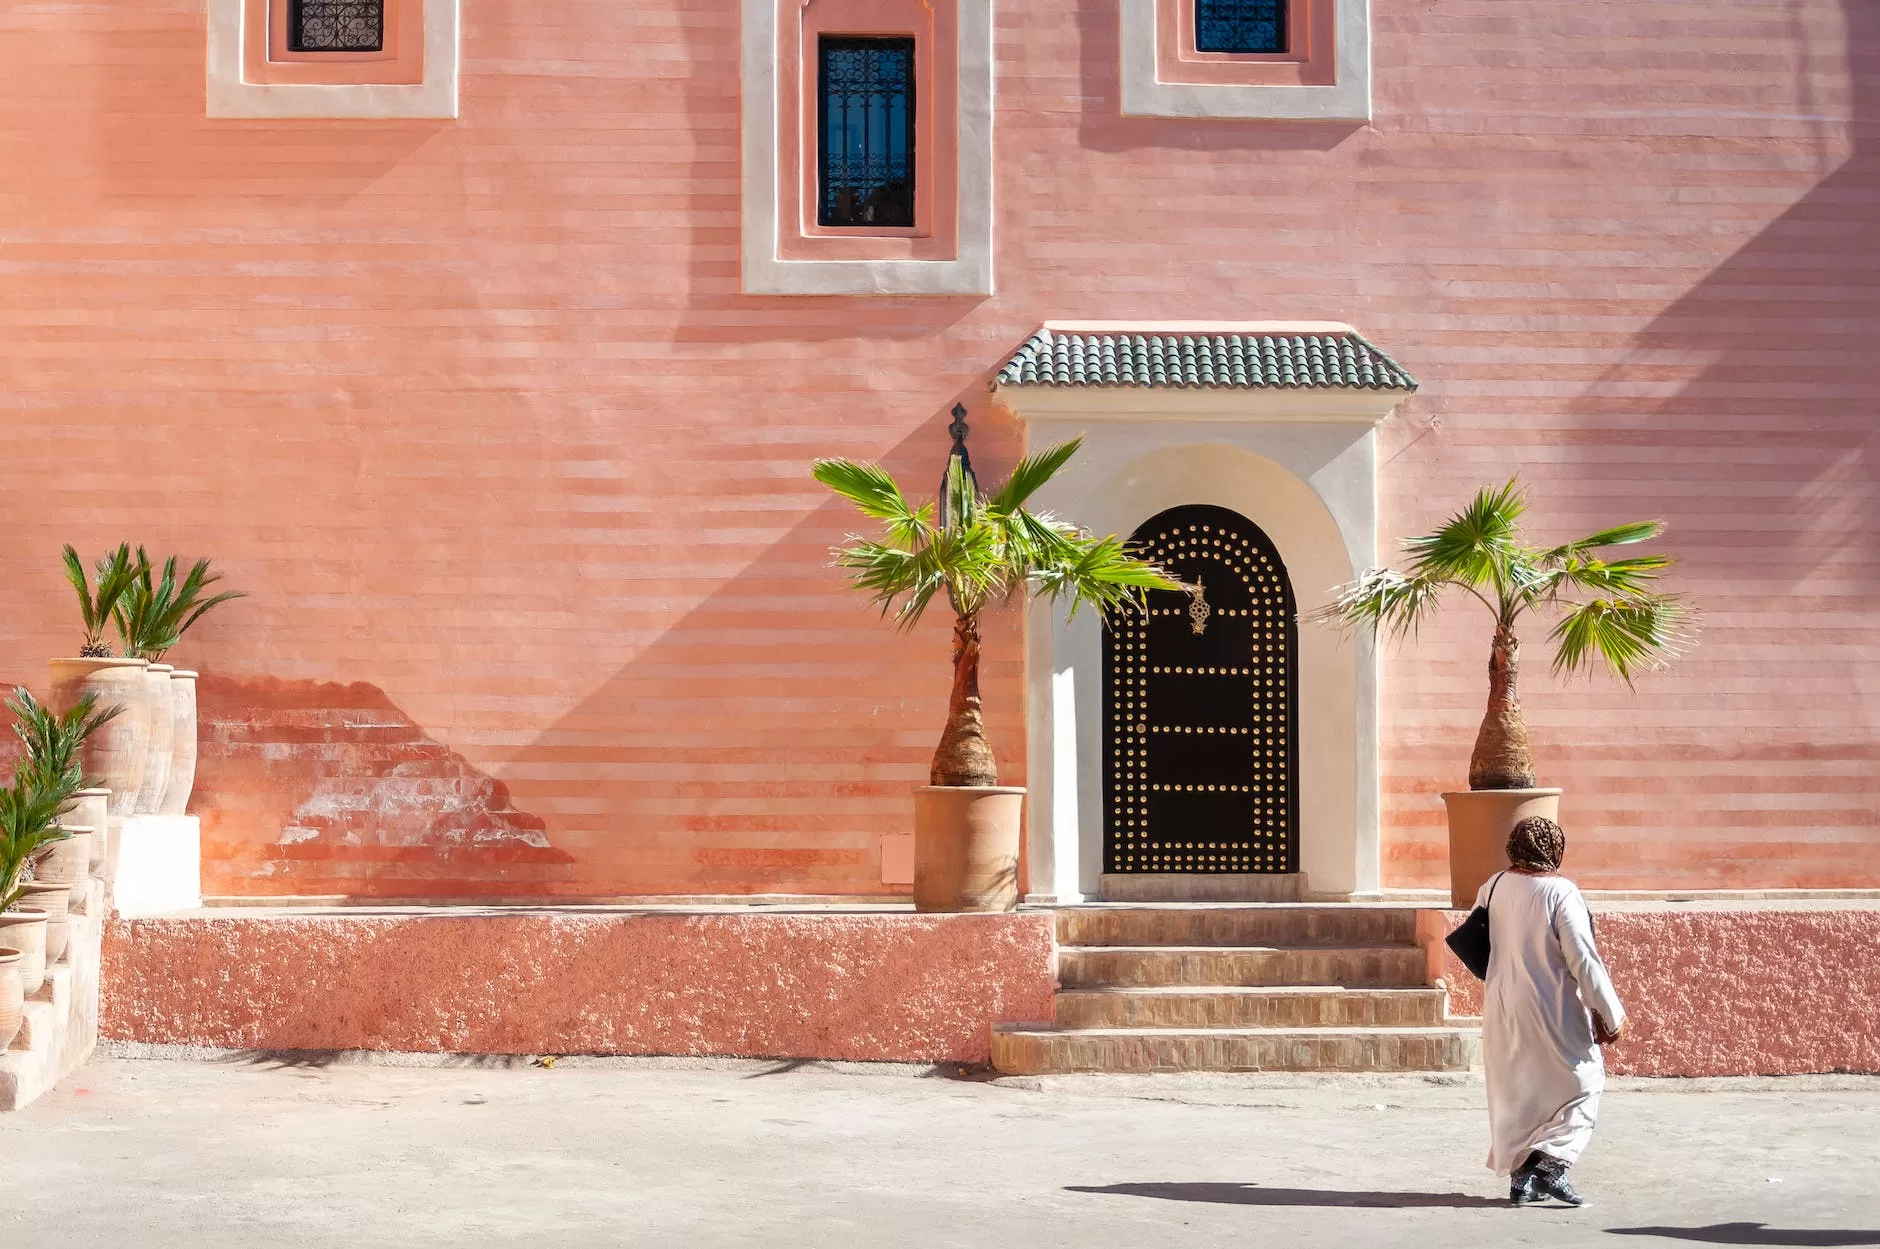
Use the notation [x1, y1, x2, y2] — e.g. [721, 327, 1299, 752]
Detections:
[1057, 986, 1444, 1029]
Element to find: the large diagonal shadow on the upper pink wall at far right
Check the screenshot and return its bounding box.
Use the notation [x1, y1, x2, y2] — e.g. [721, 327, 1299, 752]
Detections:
[1572, 0, 1880, 593]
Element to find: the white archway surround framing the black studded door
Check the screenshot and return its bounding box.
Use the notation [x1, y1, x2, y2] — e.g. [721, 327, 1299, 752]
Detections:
[993, 322, 1404, 903]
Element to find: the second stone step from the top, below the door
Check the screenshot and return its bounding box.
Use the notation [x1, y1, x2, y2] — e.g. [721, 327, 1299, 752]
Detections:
[1058, 946, 1429, 989]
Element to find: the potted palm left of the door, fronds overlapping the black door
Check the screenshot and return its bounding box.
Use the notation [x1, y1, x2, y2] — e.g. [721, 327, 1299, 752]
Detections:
[812, 406, 1184, 910]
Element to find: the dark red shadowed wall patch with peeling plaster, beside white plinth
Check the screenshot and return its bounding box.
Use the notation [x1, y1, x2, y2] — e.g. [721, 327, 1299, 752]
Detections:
[190, 672, 573, 897]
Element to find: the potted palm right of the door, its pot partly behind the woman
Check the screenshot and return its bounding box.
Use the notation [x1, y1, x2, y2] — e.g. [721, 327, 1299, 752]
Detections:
[1314, 482, 1690, 907]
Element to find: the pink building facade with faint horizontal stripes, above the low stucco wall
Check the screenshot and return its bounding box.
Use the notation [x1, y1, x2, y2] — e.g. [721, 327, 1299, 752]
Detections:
[0, 0, 1880, 901]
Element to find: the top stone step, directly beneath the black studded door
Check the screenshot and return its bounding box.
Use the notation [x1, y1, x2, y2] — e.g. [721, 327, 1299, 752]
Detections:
[1057, 905, 1418, 946]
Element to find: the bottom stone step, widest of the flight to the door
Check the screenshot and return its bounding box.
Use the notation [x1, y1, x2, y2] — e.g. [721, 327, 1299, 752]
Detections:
[993, 1025, 1481, 1076]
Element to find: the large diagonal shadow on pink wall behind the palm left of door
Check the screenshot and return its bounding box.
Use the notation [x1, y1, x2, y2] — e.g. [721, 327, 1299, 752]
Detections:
[485, 397, 1025, 895]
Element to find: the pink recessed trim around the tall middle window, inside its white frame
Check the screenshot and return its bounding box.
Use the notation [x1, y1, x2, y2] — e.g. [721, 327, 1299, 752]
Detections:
[776, 0, 959, 260]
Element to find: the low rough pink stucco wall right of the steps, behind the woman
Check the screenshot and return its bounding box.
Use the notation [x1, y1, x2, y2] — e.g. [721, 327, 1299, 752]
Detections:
[1444, 905, 1880, 1076]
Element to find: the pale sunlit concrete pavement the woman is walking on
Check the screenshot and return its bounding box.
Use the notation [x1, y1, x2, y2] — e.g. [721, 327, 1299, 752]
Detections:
[0, 1059, 1880, 1249]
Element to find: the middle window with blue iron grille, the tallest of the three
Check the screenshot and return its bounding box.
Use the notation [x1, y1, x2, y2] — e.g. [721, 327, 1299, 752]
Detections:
[816, 36, 914, 226]
